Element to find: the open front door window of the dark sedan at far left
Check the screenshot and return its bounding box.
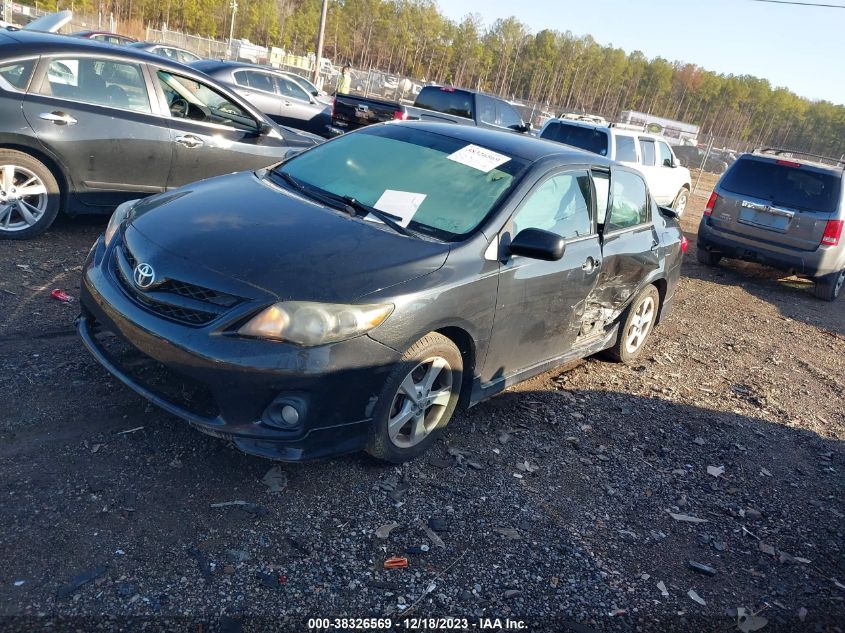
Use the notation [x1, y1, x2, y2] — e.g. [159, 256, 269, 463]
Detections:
[157, 70, 258, 130]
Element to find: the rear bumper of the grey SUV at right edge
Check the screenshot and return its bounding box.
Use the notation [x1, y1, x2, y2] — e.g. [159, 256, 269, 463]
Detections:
[698, 216, 845, 277]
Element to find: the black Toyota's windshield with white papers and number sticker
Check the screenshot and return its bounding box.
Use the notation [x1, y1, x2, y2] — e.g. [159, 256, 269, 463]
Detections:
[277, 125, 528, 241]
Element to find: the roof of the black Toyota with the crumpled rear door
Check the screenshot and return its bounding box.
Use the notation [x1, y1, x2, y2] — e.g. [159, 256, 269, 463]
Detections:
[386, 121, 613, 167]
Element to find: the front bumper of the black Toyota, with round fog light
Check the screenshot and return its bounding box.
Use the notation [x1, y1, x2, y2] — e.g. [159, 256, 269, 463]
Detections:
[78, 239, 399, 461]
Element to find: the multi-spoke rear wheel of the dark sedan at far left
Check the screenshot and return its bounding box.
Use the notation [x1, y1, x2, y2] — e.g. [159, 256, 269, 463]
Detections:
[0, 150, 61, 240]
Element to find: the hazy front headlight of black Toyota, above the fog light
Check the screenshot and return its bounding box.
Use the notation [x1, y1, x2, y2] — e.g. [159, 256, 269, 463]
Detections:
[238, 301, 393, 347]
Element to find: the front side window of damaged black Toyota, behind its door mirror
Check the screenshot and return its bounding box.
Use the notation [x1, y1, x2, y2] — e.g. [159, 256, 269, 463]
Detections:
[513, 172, 593, 239]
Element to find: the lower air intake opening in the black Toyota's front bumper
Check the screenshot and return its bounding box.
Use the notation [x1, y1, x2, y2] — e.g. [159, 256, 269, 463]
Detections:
[96, 330, 220, 418]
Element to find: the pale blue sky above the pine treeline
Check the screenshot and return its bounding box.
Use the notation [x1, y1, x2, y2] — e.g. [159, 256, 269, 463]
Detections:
[437, 0, 845, 104]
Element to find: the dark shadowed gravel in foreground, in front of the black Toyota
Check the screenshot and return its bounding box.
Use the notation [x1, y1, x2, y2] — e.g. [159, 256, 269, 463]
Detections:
[0, 374, 845, 632]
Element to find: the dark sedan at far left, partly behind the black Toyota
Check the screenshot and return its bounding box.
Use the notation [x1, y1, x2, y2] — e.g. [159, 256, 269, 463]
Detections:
[0, 28, 323, 239]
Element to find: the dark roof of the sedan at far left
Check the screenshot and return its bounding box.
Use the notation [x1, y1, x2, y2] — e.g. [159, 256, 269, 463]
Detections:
[0, 30, 185, 72]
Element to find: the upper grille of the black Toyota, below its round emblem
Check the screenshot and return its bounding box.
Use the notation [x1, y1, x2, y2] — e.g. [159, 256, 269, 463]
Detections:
[114, 244, 243, 326]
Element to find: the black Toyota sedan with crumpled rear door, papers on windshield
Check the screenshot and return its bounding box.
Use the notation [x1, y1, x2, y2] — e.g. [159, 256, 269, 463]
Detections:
[78, 122, 686, 462]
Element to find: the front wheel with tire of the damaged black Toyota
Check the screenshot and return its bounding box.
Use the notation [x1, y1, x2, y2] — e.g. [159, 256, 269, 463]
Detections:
[366, 332, 463, 464]
